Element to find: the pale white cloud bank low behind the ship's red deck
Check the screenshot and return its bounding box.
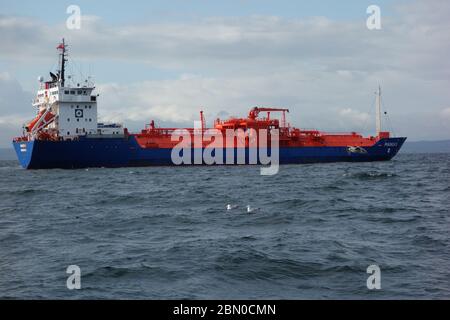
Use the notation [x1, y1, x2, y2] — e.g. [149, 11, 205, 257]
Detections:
[93, 72, 382, 133]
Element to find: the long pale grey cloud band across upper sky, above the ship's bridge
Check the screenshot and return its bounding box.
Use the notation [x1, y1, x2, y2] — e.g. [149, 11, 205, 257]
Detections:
[0, 1, 450, 77]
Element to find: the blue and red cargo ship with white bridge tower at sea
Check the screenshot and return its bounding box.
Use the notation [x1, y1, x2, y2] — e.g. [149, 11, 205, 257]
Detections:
[13, 39, 406, 169]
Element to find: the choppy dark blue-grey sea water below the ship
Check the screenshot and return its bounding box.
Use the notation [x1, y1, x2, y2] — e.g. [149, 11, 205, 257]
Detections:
[0, 154, 450, 299]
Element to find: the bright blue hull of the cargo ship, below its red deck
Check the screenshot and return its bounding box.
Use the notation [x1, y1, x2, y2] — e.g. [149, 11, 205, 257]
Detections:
[13, 136, 406, 169]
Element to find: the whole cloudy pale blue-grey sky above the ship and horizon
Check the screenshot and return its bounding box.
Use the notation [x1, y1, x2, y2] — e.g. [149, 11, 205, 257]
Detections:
[0, 0, 450, 147]
